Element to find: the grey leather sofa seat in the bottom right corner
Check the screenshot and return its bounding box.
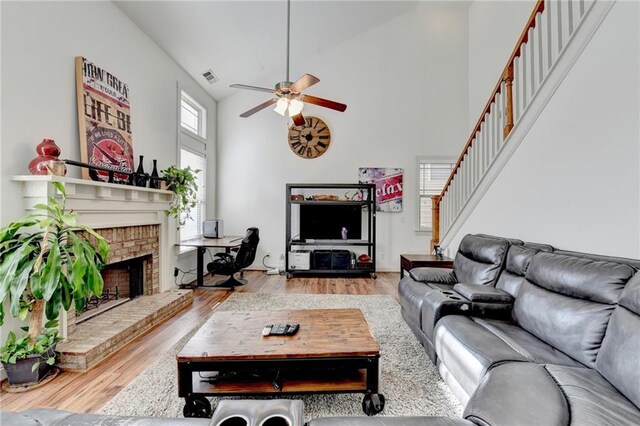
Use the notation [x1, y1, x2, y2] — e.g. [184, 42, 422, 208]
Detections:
[545, 365, 640, 426]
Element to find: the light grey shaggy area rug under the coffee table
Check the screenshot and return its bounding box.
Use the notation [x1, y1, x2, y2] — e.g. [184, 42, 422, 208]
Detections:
[100, 292, 462, 420]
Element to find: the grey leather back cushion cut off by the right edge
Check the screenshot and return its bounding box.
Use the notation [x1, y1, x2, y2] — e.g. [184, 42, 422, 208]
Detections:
[596, 273, 640, 410]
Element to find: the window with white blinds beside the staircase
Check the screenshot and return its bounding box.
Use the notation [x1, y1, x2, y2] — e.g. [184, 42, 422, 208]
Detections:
[418, 159, 455, 231]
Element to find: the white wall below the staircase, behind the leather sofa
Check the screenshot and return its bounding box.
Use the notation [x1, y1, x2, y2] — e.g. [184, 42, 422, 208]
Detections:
[449, 1, 640, 258]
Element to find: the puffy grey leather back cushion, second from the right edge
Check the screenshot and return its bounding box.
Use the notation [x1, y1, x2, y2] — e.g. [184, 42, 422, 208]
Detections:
[512, 253, 634, 367]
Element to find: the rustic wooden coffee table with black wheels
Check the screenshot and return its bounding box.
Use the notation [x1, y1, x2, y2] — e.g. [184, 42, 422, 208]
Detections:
[176, 309, 384, 417]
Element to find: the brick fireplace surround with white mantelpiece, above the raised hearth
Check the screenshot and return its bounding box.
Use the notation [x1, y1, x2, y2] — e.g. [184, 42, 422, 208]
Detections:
[13, 176, 176, 337]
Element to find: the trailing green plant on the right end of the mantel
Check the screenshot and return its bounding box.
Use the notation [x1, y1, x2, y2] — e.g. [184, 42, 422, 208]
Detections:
[162, 166, 200, 226]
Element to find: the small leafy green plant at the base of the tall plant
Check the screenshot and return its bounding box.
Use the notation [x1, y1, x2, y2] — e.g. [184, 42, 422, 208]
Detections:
[0, 320, 62, 372]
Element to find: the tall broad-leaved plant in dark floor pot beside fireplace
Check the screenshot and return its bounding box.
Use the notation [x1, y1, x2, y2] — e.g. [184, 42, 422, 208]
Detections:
[0, 182, 109, 385]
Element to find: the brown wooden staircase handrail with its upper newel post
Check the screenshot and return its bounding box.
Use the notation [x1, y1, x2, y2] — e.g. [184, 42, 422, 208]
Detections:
[440, 0, 545, 199]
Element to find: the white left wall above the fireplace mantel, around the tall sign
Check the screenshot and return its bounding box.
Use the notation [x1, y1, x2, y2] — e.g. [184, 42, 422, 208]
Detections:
[0, 2, 216, 341]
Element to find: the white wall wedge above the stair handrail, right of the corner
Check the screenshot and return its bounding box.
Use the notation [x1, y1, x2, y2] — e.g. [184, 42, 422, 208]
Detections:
[467, 0, 536, 131]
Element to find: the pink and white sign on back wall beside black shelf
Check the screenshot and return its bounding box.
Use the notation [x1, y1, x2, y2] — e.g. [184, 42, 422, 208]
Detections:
[358, 167, 404, 213]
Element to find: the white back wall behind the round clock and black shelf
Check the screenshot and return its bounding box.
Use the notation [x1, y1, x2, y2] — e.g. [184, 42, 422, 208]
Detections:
[217, 2, 467, 270]
